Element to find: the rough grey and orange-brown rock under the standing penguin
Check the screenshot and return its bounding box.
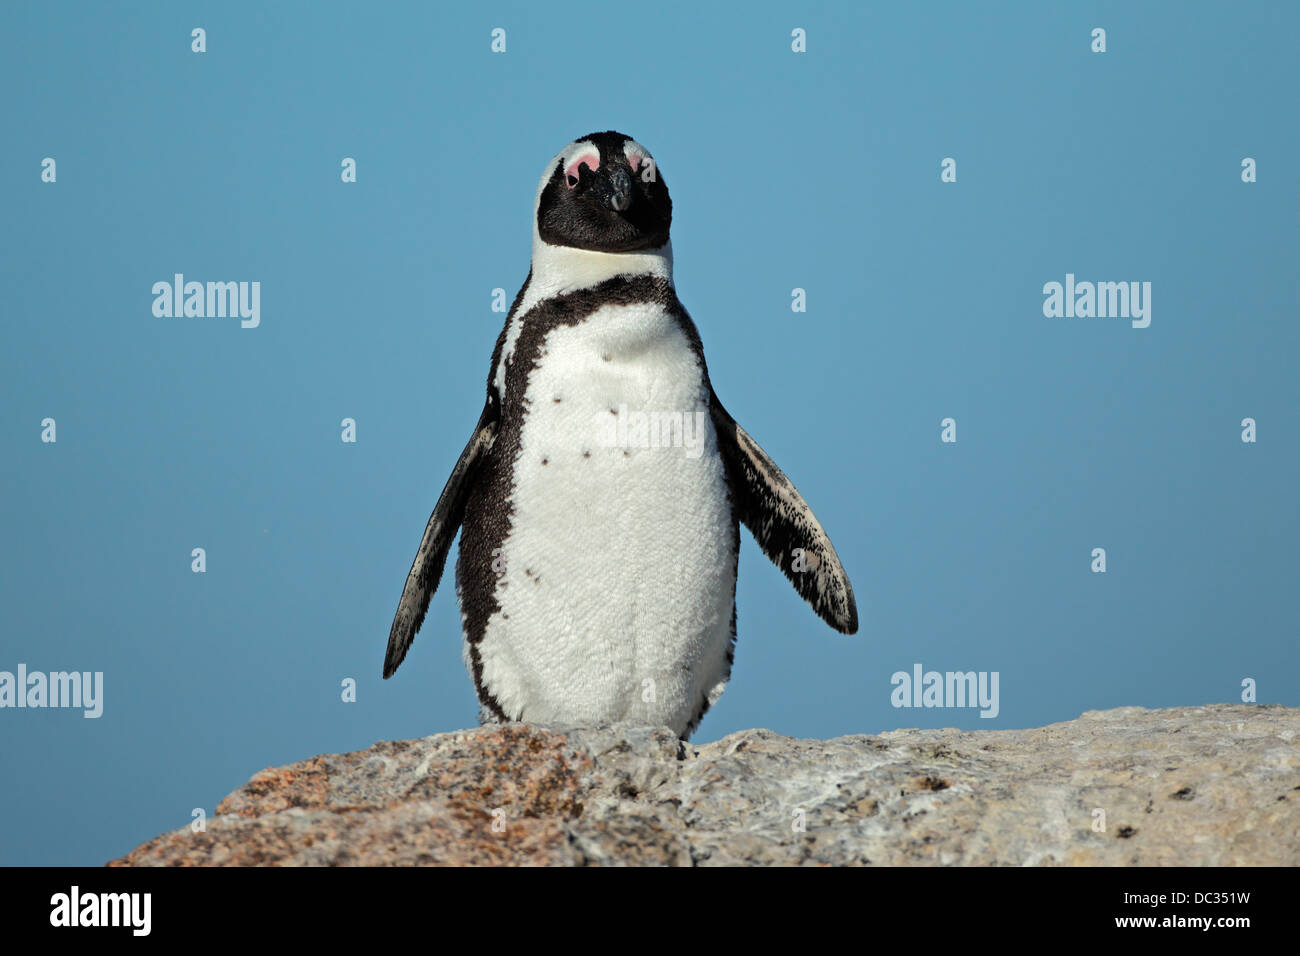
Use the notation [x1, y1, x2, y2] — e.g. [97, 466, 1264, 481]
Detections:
[111, 705, 1300, 866]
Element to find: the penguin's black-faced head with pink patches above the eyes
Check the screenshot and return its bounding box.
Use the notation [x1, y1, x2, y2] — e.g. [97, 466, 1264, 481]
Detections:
[536, 130, 672, 254]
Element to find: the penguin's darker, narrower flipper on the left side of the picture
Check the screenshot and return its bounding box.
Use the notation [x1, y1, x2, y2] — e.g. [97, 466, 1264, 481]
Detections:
[384, 401, 497, 680]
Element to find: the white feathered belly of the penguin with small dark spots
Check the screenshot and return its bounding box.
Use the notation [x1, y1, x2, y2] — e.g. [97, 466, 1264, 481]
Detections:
[458, 303, 738, 735]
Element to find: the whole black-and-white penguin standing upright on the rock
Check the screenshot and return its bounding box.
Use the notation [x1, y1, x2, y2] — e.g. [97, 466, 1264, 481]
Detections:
[384, 130, 858, 740]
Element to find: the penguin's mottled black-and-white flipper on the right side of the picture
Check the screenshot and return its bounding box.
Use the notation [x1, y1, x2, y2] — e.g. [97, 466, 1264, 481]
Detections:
[710, 394, 858, 633]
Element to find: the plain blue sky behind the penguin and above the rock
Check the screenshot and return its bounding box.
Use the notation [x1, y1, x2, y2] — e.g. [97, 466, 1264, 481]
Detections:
[0, 3, 1300, 864]
